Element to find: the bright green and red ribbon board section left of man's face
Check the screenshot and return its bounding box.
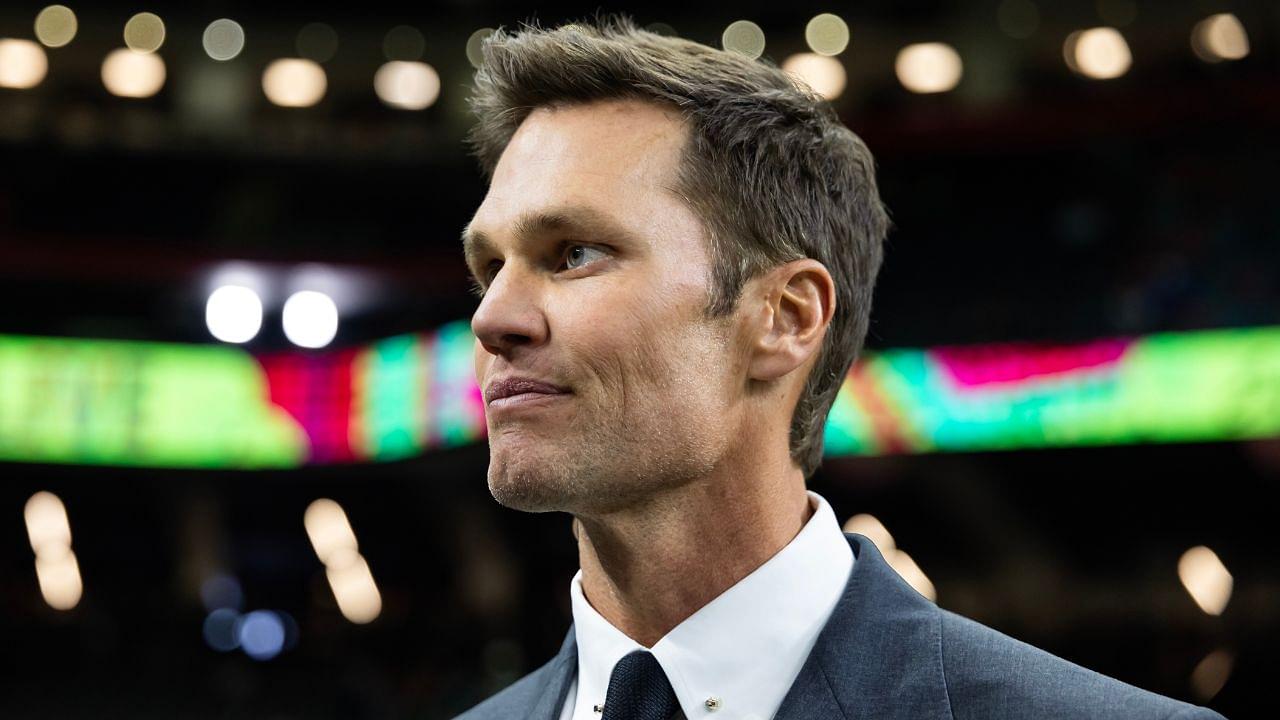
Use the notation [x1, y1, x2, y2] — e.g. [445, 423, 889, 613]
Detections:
[0, 323, 485, 469]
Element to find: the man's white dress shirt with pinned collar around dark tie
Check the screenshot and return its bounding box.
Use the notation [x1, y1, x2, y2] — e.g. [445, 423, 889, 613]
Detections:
[559, 492, 854, 720]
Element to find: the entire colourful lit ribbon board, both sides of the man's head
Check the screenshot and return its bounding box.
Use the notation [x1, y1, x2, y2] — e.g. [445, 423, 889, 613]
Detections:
[0, 322, 1280, 469]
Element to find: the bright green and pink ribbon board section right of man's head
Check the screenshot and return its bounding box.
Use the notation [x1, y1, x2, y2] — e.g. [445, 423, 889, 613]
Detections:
[826, 327, 1280, 455]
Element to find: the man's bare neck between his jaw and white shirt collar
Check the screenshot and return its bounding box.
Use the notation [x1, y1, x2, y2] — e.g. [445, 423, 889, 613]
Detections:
[576, 459, 813, 647]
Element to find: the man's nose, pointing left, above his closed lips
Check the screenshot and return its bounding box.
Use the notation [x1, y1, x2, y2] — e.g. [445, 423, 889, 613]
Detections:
[471, 264, 547, 359]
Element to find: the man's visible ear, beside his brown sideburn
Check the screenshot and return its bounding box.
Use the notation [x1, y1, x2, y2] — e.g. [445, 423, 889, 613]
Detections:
[748, 258, 836, 380]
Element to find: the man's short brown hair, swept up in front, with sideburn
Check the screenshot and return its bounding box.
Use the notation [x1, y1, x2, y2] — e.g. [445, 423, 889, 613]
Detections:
[468, 18, 888, 478]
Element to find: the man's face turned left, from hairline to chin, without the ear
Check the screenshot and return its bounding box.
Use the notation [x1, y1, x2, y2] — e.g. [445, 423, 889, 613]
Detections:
[466, 100, 745, 515]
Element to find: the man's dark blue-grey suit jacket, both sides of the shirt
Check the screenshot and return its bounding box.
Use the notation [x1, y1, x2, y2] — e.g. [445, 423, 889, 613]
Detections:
[458, 534, 1222, 720]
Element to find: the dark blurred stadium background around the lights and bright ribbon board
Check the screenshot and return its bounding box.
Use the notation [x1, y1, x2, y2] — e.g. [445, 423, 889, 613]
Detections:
[0, 0, 1280, 719]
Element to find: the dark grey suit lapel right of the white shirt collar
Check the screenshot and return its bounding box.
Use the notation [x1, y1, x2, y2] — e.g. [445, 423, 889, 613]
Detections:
[774, 534, 951, 720]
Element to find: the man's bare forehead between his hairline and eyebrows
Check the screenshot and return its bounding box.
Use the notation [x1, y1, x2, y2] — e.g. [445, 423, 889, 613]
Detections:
[467, 100, 687, 245]
